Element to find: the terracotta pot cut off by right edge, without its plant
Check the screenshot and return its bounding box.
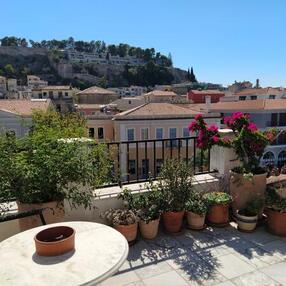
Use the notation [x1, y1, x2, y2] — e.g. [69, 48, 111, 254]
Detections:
[266, 209, 286, 236]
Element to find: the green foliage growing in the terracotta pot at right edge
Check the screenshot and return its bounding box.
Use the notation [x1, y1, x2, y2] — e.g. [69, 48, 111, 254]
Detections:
[265, 186, 286, 213]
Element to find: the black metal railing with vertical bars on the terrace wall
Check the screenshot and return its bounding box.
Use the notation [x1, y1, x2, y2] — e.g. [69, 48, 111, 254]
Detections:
[104, 137, 212, 186]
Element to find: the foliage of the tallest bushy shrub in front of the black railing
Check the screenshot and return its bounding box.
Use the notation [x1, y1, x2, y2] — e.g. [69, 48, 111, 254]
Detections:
[155, 159, 193, 212]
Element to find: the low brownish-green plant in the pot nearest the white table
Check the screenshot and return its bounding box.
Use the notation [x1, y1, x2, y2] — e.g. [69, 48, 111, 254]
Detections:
[102, 209, 138, 225]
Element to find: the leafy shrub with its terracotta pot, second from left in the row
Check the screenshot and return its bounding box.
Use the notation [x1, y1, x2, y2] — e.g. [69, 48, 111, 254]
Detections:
[119, 188, 161, 239]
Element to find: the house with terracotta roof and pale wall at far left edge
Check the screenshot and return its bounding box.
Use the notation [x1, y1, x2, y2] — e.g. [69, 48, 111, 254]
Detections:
[0, 99, 53, 137]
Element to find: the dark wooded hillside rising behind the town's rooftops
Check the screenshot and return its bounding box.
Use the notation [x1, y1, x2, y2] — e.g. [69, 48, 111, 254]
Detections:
[0, 42, 187, 88]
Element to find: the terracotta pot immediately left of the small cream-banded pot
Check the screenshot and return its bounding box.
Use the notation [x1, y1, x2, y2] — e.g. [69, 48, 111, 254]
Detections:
[207, 204, 229, 226]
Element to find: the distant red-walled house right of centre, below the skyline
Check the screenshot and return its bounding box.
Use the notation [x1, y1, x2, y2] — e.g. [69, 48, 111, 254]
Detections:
[187, 89, 225, 103]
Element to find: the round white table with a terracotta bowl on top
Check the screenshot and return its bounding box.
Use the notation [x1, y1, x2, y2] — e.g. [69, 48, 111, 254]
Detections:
[0, 221, 129, 286]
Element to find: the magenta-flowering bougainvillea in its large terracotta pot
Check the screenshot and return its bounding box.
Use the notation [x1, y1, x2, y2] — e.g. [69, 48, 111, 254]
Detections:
[189, 112, 277, 214]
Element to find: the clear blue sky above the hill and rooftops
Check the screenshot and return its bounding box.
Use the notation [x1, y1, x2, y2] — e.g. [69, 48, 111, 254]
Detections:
[0, 0, 286, 86]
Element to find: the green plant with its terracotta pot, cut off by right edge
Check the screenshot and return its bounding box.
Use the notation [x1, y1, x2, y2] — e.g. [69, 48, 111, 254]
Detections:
[265, 186, 286, 236]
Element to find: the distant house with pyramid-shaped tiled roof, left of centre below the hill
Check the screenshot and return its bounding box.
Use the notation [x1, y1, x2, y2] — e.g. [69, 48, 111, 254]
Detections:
[76, 86, 120, 104]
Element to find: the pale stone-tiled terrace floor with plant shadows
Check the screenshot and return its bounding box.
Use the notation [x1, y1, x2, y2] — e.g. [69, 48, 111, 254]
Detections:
[101, 224, 286, 286]
